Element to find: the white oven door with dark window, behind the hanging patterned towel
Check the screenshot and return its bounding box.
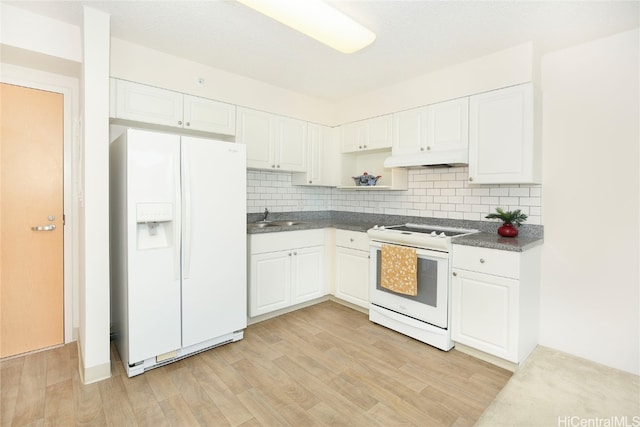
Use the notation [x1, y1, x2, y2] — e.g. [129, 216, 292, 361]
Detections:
[369, 241, 449, 329]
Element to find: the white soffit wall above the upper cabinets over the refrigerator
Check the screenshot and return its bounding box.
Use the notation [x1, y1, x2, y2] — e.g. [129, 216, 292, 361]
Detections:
[111, 38, 334, 124]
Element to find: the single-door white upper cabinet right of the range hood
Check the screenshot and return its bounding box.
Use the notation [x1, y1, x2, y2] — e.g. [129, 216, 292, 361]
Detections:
[469, 83, 540, 184]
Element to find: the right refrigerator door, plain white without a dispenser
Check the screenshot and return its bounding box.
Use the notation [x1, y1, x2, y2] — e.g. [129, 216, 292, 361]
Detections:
[182, 137, 247, 347]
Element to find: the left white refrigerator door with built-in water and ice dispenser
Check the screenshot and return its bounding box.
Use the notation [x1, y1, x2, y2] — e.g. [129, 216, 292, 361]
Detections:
[126, 130, 181, 364]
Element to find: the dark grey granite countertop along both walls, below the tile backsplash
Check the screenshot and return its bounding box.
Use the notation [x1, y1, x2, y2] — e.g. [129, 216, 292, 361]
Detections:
[247, 211, 544, 252]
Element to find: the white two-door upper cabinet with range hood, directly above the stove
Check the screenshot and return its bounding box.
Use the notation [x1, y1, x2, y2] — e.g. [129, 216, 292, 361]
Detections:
[385, 98, 469, 167]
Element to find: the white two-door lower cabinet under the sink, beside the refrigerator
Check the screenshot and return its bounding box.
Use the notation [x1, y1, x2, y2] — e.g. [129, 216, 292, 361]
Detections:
[249, 230, 327, 317]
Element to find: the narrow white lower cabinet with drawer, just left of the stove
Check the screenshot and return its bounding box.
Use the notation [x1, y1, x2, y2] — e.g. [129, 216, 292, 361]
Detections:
[335, 230, 369, 308]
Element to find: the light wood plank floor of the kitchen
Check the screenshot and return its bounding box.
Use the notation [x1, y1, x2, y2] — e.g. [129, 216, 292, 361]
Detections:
[0, 301, 511, 427]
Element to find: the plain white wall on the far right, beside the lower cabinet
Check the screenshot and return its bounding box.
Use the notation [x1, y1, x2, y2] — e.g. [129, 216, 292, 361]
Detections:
[541, 30, 640, 374]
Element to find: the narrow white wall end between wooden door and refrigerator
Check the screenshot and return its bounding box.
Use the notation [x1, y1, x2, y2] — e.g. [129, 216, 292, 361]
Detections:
[79, 6, 111, 383]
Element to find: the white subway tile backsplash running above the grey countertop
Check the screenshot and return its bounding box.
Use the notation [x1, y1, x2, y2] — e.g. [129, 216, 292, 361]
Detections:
[247, 167, 542, 224]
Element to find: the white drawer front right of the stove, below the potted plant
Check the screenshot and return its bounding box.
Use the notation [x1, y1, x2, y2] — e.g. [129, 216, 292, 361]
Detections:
[453, 245, 520, 279]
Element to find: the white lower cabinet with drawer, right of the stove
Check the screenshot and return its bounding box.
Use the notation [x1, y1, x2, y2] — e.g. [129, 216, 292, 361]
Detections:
[451, 245, 540, 364]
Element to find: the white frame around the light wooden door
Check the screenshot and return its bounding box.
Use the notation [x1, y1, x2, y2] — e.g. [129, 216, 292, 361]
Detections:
[0, 63, 82, 344]
